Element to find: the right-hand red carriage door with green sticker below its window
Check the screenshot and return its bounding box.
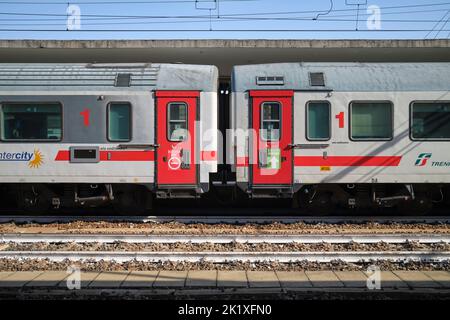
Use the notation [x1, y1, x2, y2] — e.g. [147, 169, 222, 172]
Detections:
[250, 90, 294, 186]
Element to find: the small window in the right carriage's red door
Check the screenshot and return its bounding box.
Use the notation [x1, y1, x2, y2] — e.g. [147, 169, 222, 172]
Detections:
[261, 102, 281, 141]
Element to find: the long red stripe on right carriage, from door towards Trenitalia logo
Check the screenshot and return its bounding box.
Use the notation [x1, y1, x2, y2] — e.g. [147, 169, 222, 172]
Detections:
[294, 156, 402, 167]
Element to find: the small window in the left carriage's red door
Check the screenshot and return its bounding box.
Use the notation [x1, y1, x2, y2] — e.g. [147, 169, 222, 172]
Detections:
[167, 102, 188, 142]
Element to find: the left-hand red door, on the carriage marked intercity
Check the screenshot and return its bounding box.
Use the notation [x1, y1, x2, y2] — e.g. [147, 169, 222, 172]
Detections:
[156, 91, 200, 186]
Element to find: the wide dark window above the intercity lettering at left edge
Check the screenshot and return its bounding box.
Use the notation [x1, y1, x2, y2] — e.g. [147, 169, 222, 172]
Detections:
[0, 102, 62, 141]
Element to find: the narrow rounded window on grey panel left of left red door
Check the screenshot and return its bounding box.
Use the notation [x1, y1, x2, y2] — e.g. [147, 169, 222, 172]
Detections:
[108, 102, 131, 141]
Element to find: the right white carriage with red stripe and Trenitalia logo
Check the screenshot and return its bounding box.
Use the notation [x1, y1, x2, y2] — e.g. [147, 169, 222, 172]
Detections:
[228, 63, 450, 209]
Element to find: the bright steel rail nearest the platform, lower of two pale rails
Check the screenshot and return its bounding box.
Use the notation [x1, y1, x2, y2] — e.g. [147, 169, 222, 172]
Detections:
[0, 251, 450, 263]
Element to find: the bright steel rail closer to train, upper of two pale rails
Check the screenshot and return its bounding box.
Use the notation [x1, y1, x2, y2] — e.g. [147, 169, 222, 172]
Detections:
[0, 233, 450, 244]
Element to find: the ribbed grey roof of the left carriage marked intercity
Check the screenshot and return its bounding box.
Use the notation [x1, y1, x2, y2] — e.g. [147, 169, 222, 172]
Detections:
[0, 63, 218, 92]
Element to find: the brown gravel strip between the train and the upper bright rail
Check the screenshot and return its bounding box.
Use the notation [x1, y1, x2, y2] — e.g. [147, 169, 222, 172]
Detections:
[0, 221, 450, 235]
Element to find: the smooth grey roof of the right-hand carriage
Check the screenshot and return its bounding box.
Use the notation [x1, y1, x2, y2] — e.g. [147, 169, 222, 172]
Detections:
[232, 62, 450, 92]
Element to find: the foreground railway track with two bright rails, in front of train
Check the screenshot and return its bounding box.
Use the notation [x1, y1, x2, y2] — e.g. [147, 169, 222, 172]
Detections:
[0, 234, 450, 263]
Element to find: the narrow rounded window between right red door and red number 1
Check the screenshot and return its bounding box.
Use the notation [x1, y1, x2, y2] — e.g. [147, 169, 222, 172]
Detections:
[306, 101, 331, 141]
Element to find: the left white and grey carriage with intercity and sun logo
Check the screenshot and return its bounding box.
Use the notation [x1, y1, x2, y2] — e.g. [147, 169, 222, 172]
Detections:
[0, 63, 218, 209]
